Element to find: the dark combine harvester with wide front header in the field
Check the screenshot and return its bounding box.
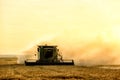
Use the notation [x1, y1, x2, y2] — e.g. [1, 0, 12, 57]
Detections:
[25, 45, 74, 65]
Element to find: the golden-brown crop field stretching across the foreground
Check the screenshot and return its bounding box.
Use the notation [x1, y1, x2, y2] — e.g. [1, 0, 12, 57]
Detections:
[0, 58, 120, 80]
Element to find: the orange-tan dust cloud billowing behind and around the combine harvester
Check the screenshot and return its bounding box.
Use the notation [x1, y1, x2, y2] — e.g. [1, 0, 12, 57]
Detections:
[17, 33, 120, 65]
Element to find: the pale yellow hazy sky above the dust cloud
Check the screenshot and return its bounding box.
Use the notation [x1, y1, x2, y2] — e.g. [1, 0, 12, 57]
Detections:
[0, 0, 120, 54]
